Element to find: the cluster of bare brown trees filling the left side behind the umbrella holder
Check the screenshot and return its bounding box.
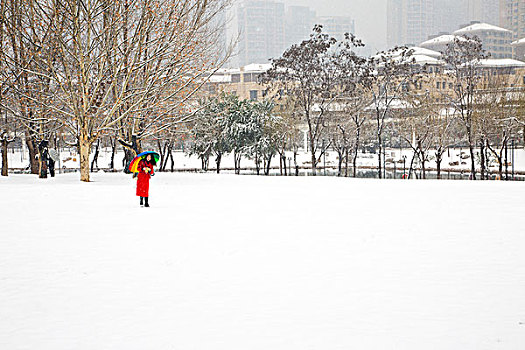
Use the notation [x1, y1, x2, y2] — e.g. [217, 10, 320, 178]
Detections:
[0, 0, 228, 181]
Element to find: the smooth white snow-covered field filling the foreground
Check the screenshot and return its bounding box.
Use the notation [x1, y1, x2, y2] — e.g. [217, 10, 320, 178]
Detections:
[0, 173, 525, 350]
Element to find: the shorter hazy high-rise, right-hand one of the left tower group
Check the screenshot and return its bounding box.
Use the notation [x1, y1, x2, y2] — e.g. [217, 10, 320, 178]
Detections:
[286, 6, 316, 48]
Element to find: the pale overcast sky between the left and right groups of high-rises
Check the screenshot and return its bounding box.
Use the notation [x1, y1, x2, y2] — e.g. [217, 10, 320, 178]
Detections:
[284, 0, 387, 52]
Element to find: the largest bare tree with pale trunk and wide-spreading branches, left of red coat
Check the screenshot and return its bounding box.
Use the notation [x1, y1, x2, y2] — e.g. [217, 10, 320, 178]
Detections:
[1, 0, 231, 181]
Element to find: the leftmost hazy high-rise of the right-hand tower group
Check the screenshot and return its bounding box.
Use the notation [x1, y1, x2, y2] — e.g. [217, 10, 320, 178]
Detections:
[387, 0, 435, 46]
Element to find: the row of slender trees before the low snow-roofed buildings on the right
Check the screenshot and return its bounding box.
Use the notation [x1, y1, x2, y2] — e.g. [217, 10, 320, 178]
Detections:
[261, 26, 525, 180]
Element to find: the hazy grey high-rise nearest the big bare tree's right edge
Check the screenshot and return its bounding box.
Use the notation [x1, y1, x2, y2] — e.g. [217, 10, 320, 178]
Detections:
[237, 0, 285, 66]
